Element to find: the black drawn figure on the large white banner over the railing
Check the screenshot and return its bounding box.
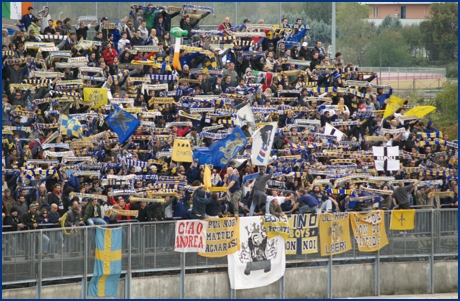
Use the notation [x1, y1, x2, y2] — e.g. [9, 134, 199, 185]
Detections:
[239, 223, 277, 275]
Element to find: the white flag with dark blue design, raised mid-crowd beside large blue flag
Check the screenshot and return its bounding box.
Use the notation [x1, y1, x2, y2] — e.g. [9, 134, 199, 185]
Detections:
[251, 122, 278, 166]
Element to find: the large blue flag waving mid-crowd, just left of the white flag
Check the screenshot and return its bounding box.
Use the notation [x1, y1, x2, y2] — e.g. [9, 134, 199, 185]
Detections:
[193, 126, 248, 168]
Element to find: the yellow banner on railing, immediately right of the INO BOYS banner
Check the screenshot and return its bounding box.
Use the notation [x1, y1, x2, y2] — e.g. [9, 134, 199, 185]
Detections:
[319, 212, 351, 256]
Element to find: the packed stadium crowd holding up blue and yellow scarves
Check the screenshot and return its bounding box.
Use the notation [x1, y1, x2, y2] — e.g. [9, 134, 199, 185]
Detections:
[2, 5, 458, 258]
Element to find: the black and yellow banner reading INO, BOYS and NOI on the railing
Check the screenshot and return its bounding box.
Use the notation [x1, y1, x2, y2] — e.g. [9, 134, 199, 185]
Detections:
[286, 214, 319, 255]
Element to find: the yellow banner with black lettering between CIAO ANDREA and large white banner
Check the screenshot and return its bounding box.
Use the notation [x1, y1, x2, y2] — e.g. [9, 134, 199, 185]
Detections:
[198, 217, 240, 258]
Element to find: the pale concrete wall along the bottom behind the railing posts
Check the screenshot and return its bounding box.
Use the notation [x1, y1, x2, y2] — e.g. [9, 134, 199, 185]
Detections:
[2, 261, 458, 299]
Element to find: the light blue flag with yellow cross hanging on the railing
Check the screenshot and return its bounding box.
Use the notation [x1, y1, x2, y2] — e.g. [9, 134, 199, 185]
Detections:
[88, 227, 122, 297]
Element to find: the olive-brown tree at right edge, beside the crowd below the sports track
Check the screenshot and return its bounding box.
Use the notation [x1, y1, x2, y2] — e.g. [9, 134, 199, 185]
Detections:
[422, 81, 458, 140]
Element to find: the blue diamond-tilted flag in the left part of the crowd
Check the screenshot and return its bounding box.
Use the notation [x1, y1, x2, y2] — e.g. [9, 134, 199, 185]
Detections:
[106, 104, 141, 143]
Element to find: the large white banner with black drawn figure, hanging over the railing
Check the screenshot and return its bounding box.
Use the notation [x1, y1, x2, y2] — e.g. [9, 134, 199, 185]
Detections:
[227, 216, 286, 289]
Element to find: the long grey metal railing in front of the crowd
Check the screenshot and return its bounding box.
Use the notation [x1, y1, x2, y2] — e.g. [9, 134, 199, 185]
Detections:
[2, 209, 458, 298]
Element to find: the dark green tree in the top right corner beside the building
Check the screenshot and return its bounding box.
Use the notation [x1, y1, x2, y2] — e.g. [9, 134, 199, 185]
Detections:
[420, 2, 458, 61]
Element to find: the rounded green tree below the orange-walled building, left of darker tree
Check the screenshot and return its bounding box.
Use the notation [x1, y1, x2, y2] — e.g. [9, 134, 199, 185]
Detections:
[364, 29, 411, 67]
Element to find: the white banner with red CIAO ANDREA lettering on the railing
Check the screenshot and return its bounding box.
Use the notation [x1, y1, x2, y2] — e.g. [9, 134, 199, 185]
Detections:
[174, 220, 208, 252]
